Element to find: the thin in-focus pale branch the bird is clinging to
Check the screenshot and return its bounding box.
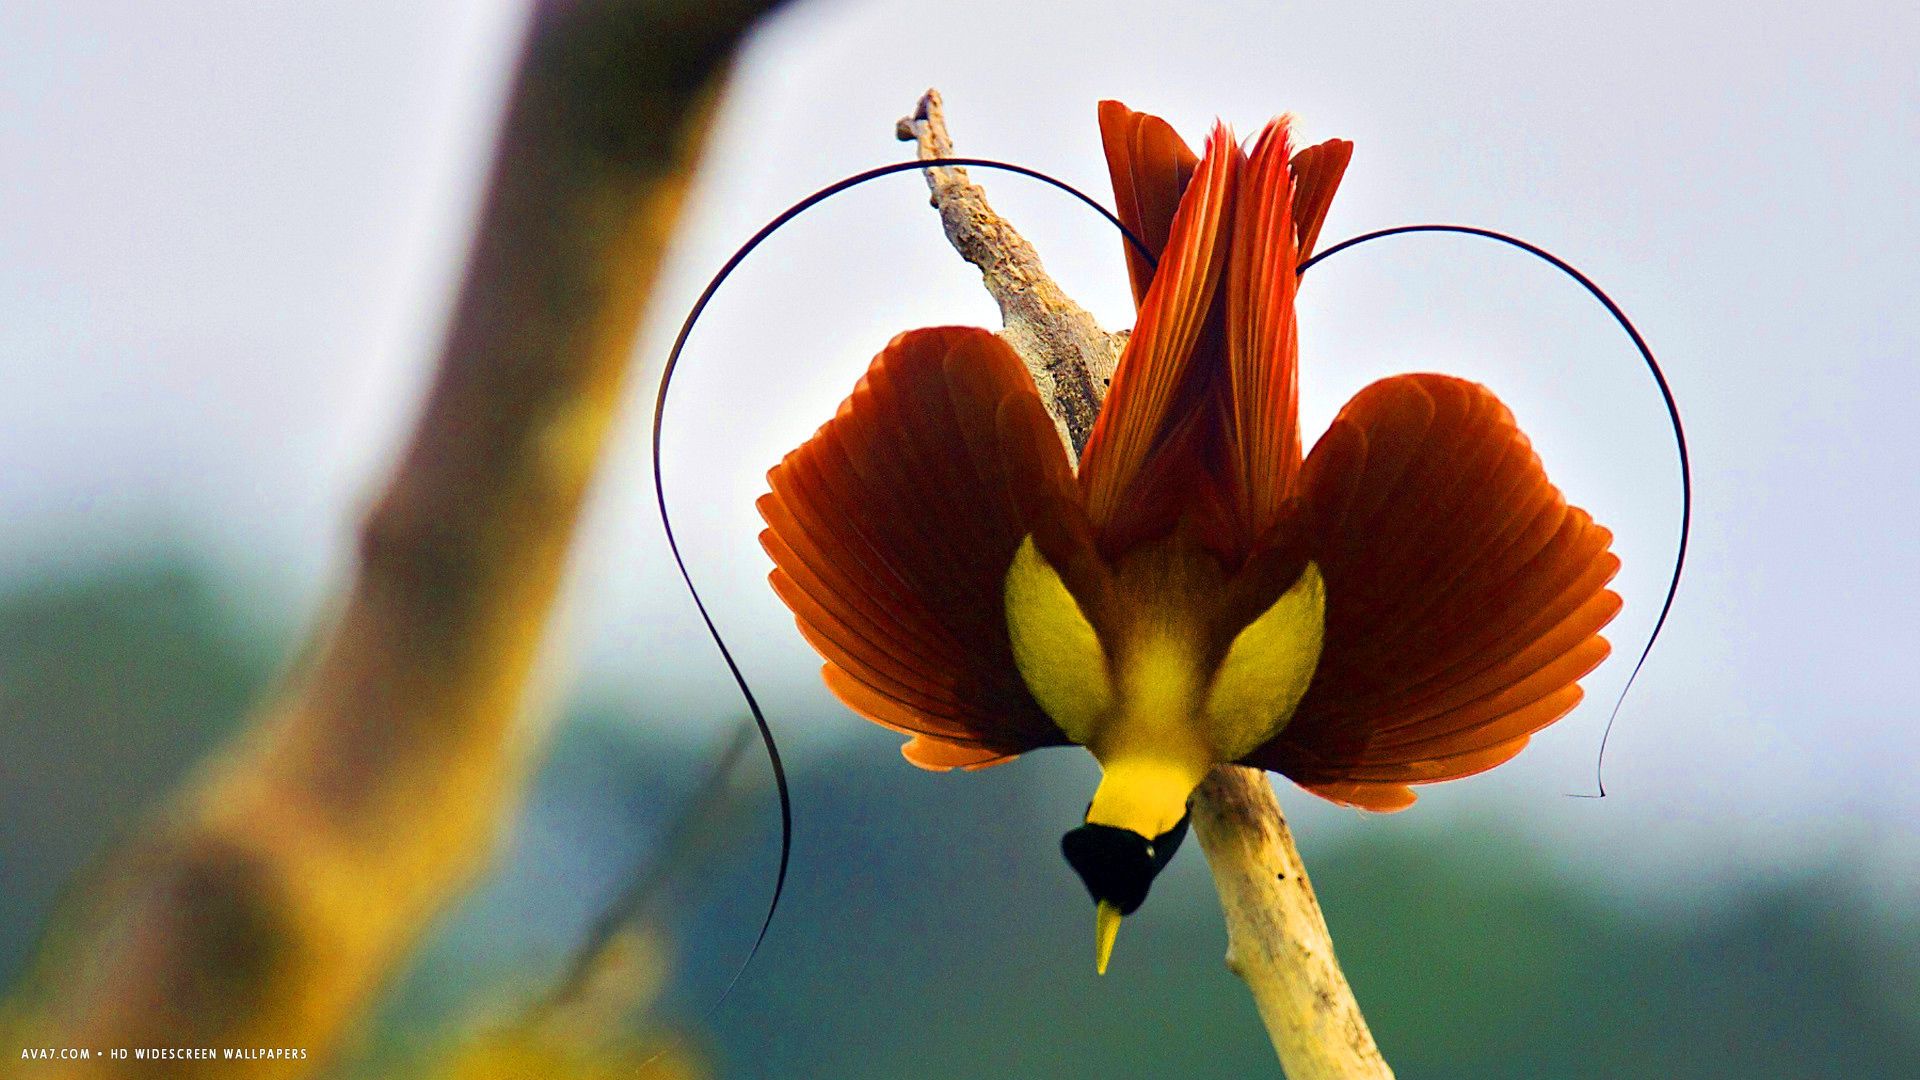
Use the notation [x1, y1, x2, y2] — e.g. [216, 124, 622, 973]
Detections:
[899, 90, 1392, 1080]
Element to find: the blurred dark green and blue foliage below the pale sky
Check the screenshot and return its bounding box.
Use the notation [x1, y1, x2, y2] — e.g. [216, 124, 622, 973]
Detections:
[0, 550, 1920, 1080]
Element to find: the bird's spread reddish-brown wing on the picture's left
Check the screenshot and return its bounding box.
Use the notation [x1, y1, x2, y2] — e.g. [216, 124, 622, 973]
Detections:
[758, 327, 1085, 769]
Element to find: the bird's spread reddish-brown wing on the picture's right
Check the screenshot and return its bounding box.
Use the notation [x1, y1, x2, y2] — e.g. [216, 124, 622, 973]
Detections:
[1246, 375, 1620, 811]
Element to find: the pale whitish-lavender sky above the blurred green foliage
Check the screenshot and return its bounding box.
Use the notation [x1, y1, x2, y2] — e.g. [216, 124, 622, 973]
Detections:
[0, 0, 1920, 894]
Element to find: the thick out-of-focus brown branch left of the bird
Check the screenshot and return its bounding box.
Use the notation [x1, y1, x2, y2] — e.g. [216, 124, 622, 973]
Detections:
[4, 0, 772, 1076]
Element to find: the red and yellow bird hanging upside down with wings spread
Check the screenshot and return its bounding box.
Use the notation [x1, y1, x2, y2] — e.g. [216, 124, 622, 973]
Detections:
[758, 102, 1620, 972]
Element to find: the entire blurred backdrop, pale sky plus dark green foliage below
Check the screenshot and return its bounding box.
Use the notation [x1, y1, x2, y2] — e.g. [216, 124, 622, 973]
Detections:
[0, 0, 1920, 1080]
